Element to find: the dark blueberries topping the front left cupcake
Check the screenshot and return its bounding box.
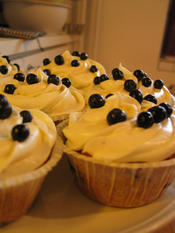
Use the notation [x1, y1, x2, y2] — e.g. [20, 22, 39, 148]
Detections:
[0, 95, 30, 142]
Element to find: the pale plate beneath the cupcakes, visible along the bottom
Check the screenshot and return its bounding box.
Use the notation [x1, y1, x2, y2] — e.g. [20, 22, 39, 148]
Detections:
[0, 159, 175, 233]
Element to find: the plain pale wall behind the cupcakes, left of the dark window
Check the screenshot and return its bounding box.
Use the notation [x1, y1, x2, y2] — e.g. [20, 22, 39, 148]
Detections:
[85, 0, 175, 84]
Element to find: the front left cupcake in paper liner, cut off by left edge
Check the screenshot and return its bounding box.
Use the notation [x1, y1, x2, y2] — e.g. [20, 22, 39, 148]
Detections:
[0, 95, 62, 225]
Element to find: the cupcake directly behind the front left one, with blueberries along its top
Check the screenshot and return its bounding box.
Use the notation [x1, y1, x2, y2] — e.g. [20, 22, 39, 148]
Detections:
[0, 68, 85, 122]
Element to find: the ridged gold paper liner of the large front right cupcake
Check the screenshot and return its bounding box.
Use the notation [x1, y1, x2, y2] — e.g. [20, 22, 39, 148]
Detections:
[59, 121, 175, 207]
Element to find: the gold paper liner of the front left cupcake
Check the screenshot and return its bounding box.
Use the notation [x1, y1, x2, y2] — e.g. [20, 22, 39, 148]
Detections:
[0, 127, 63, 225]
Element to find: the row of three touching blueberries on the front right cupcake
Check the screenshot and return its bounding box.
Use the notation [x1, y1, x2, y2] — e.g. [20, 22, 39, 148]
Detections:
[137, 103, 173, 129]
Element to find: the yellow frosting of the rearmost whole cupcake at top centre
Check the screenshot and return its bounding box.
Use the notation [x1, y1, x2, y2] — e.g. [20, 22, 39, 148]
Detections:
[42, 51, 106, 89]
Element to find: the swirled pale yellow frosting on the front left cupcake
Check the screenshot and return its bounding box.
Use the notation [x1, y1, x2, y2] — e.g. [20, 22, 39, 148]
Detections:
[0, 104, 56, 179]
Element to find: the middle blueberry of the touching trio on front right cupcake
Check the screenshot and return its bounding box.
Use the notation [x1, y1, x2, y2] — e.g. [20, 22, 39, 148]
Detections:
[148, 106, 167, 123]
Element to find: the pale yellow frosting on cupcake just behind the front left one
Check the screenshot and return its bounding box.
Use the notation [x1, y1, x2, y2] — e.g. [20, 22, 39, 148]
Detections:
[0, 69, 85, 120]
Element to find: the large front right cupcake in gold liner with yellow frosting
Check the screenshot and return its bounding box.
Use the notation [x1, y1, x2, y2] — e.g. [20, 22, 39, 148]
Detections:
[59, 69, 175, 207]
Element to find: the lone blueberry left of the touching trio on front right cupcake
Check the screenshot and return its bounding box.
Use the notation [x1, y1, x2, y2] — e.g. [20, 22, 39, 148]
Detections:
[107, 108, 127, 125]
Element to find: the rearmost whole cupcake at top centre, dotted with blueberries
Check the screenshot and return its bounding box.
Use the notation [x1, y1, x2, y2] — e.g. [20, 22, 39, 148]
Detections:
[42, 51, 106, 94]
